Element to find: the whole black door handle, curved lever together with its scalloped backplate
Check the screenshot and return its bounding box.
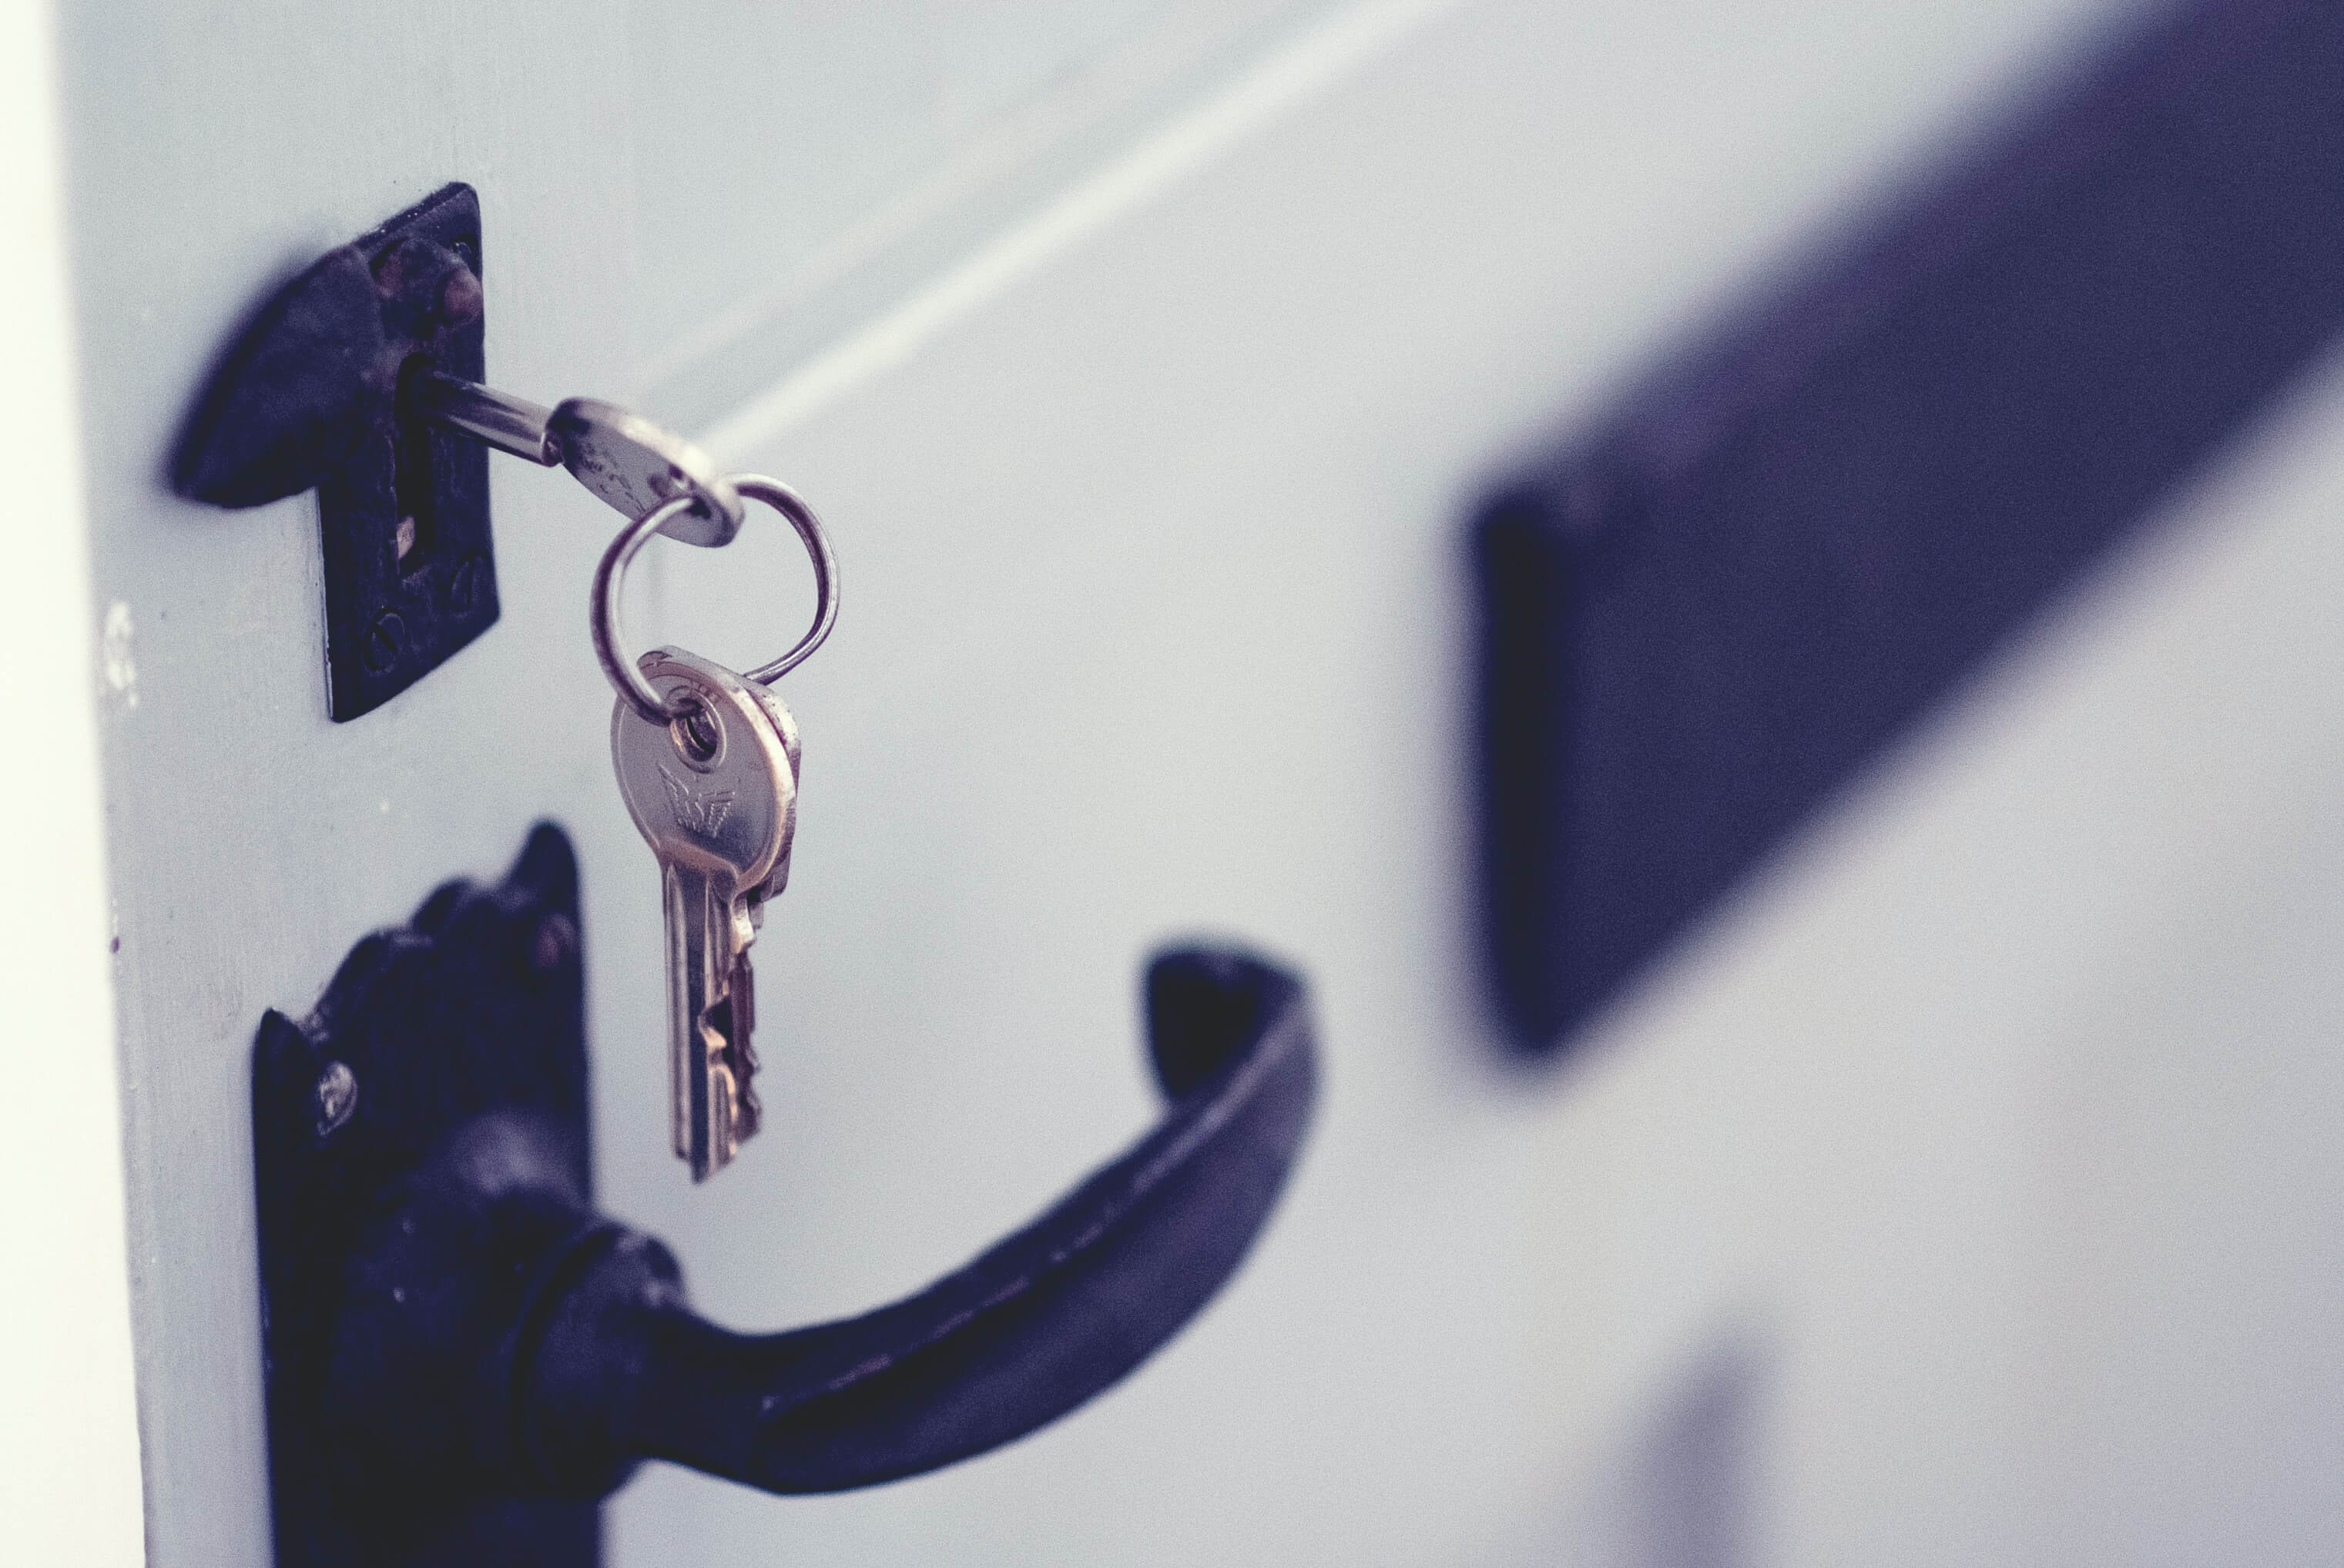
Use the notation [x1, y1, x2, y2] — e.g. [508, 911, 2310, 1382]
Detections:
[253, 827, 1317, 1568]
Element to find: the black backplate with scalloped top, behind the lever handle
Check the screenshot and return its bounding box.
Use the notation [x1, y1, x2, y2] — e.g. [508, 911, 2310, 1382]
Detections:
[253, 827, 595, 1568]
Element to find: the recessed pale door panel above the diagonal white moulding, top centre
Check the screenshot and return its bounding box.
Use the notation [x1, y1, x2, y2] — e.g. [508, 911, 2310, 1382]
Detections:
[628, 0, 1355, 429]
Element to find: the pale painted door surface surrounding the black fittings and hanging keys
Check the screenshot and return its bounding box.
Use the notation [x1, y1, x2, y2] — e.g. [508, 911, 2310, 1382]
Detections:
[50, 0, 2344, 1568]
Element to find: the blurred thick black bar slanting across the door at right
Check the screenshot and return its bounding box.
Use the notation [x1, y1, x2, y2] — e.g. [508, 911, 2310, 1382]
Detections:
[1474, 0, 2344, 1050]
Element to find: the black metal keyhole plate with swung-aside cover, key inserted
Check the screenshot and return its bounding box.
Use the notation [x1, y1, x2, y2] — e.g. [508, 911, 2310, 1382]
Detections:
[171, 185, 497, 719]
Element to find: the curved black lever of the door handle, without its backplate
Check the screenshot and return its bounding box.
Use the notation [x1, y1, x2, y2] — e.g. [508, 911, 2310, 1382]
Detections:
[523, 952, 1313, 1493]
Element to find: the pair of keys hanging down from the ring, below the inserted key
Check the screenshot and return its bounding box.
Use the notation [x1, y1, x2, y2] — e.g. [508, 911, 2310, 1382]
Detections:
[609, 647, 797, 1181]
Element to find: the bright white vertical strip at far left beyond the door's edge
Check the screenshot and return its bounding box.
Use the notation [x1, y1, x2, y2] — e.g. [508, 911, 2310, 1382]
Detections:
[0, 5, 146, 1568]
